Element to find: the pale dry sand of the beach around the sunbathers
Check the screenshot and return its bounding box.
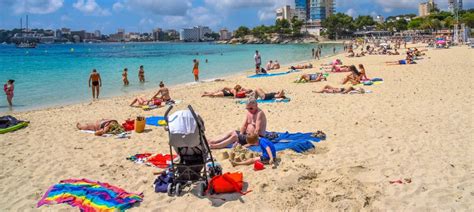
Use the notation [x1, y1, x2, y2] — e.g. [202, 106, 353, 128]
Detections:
[0, 46, 474, 211]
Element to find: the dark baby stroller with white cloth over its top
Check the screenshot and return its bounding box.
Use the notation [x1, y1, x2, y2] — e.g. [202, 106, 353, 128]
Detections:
[165, 105, 222, 196]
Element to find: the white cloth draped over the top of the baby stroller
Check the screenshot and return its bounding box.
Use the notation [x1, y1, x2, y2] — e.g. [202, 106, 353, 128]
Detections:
[168, 110, 197, 135]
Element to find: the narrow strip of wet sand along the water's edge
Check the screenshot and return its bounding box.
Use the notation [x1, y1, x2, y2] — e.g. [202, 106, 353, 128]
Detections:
[0, 49, 345, 115]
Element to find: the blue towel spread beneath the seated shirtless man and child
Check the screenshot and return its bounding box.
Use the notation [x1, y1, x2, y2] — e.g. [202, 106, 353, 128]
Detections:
[228, 132, 321, 153]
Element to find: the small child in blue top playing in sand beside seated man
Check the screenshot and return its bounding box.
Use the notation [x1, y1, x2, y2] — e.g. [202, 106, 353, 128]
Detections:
[231, 133, 276, 166]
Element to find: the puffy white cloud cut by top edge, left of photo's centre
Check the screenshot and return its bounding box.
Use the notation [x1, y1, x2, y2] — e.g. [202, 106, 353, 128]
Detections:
[124, 0, 192, 16]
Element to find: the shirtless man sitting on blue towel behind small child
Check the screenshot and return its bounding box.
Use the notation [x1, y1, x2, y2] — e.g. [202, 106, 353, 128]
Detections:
[208, 98, 267, 149]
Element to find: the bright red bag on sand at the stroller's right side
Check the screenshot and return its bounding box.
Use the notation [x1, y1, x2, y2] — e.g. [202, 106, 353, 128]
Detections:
[207, 172, 251, 195]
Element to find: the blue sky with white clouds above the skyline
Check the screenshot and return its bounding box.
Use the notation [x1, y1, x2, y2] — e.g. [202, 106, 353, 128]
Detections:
[0, 0, 474, 34]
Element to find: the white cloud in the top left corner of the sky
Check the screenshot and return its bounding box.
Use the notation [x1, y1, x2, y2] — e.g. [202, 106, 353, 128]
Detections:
[10, 0, 64, 14]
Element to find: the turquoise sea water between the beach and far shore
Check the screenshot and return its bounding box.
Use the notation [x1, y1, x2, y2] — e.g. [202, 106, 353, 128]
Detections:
[0, 43, 342, 112]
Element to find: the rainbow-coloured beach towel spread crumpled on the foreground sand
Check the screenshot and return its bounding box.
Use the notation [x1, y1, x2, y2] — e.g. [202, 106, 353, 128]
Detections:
[36, 179, 143, 211]
